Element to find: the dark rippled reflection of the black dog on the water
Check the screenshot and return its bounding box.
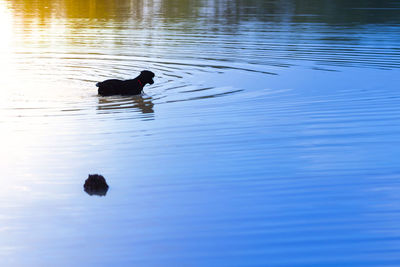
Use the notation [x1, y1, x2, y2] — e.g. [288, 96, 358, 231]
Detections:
[97, 95, 154, 114]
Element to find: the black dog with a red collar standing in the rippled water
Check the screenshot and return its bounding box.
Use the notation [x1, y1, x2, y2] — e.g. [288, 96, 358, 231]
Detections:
[96, 70, 155, 96]
